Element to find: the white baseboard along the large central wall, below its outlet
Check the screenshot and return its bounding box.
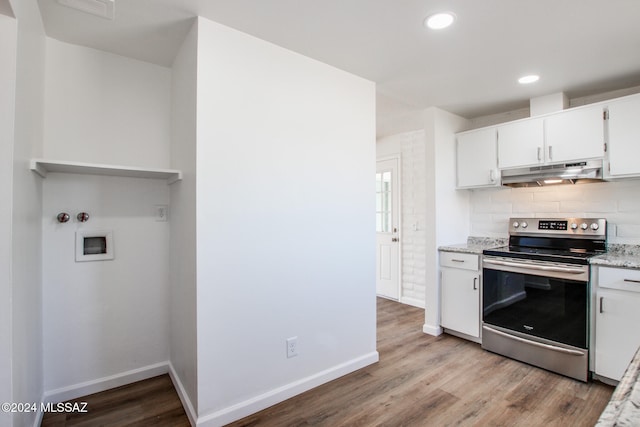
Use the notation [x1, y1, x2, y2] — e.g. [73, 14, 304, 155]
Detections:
[196, 351, 379, 427]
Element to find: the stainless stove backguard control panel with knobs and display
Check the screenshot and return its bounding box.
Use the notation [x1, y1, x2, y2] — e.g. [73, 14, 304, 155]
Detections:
[509, 218, 607, 239]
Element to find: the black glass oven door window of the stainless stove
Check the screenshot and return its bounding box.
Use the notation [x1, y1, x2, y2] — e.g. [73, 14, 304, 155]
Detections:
[482, 268, 588, 349]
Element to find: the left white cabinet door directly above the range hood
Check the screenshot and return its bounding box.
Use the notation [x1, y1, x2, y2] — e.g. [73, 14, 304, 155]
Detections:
[498, 118, 545, 169]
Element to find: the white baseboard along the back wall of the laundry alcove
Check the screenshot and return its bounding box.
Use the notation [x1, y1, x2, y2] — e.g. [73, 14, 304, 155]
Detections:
[42, 362, 169, 403]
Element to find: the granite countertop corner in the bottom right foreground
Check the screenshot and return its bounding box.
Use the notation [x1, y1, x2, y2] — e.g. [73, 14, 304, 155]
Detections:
[596, 349, 640, 427]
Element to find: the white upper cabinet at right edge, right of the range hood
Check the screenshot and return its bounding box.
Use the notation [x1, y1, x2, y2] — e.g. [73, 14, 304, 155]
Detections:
[607, 95, 640, 177]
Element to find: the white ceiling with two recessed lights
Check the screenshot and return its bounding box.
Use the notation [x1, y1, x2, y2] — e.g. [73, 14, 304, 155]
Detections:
[38, 0, 640, 118]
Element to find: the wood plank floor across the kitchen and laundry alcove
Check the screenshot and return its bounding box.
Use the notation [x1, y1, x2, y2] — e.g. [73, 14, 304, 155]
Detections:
[42, 298, 613, 427]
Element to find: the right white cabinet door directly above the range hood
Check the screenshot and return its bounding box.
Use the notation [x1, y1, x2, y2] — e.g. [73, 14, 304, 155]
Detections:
[545, 105, 604, 163]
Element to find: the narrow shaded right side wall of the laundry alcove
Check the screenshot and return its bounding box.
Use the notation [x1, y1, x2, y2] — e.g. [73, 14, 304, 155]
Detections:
[169, 22, 198, 420]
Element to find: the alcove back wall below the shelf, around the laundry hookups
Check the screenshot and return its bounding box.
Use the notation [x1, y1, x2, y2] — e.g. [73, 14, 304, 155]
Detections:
[42, 174, 169, 400]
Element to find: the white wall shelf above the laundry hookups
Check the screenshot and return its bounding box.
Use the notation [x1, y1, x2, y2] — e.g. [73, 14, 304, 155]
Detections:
[30, 159, 182, 185]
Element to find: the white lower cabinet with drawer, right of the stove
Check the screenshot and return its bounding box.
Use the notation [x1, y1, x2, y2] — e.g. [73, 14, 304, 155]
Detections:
[593, 267, 640, 381]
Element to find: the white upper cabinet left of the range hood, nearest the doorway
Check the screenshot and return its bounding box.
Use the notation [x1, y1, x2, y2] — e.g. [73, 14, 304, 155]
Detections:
[456, 127, 500, 188]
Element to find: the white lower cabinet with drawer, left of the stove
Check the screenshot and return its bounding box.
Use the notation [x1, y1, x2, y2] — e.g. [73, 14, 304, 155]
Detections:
[440, 252, 481, 341]
